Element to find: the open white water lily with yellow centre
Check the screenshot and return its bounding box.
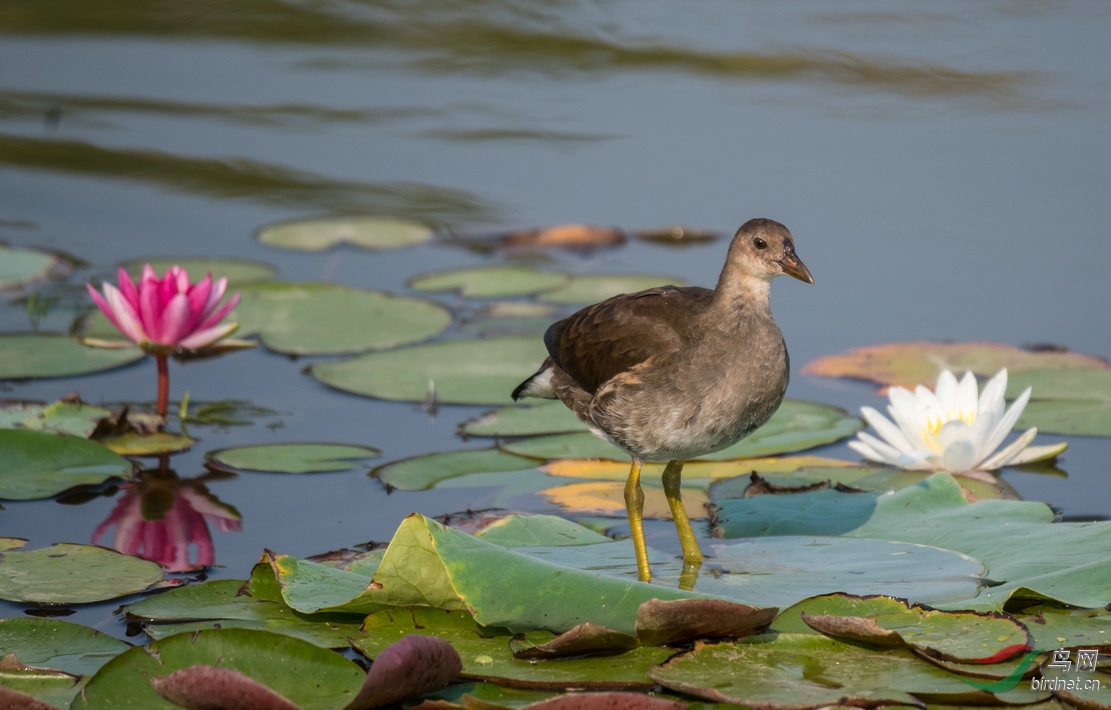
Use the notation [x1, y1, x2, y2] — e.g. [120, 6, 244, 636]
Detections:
[849, 370, 1069, 473]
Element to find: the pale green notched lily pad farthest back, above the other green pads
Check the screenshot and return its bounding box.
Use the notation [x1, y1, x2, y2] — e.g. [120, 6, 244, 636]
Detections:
[256, 217, 433, 251]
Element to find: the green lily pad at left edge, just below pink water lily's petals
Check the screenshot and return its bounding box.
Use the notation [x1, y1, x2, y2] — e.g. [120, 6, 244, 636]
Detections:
[0, 332, 146, 380]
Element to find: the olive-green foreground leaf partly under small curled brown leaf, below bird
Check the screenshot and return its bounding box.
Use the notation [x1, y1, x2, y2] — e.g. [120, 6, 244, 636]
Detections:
[352, 607, 673, 690]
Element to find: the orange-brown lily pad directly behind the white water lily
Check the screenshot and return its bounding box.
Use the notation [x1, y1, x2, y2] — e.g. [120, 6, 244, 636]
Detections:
[802, 341, 1108, 389]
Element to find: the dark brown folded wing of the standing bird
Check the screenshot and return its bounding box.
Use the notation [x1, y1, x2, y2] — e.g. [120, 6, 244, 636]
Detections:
[544, 286, 713, 394]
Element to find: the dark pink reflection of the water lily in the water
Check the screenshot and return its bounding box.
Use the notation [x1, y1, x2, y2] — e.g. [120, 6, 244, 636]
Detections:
[92, 463, 241, 572]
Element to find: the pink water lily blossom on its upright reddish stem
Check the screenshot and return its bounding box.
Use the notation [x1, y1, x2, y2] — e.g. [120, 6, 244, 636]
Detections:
[84, 263, 239, 419]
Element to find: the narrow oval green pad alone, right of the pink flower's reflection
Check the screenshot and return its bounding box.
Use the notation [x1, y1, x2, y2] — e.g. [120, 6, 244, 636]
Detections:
[204, 443, 381, 473]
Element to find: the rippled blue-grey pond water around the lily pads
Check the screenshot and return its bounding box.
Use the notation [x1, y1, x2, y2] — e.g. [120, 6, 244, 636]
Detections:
[0, 0, 1111, 634]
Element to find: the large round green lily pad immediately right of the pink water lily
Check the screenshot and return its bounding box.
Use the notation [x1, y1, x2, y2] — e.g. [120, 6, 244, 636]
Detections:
[229, 281, 451, 354]
